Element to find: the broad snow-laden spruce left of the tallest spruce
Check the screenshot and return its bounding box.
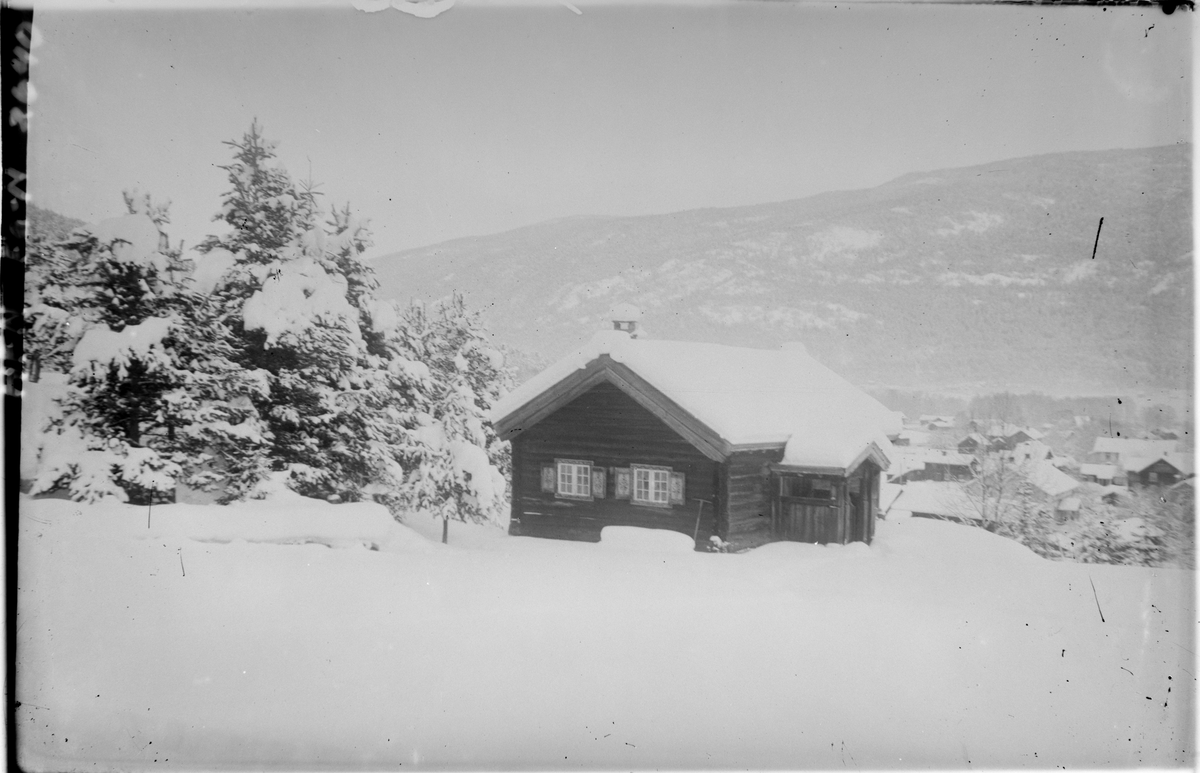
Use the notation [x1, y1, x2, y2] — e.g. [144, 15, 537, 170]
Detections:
[34, 194, 270, 503]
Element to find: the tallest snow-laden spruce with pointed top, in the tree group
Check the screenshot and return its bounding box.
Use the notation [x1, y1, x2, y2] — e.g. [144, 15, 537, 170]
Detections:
[194, 124, 427, 501]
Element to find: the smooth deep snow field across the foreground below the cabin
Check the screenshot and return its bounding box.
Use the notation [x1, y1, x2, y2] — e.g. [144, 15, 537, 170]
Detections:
[16, 495, 1195, 771]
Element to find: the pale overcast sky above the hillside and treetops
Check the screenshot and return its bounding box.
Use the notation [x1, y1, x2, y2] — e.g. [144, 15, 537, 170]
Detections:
[30, 0, 1194, 254]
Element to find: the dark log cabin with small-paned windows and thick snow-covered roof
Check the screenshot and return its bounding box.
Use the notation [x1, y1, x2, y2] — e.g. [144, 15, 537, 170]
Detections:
[492, 330, 901, 550]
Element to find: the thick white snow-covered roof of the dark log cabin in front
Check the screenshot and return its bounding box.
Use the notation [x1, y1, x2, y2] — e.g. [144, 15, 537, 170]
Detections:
[491, 330, 900, 468]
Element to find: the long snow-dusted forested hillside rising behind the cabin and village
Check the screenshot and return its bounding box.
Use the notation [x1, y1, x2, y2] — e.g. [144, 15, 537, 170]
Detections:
[373, 145, 1193, 394]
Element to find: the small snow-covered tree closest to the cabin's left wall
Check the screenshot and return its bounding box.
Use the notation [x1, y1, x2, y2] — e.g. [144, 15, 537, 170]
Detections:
[404, 294, 511, 541]
